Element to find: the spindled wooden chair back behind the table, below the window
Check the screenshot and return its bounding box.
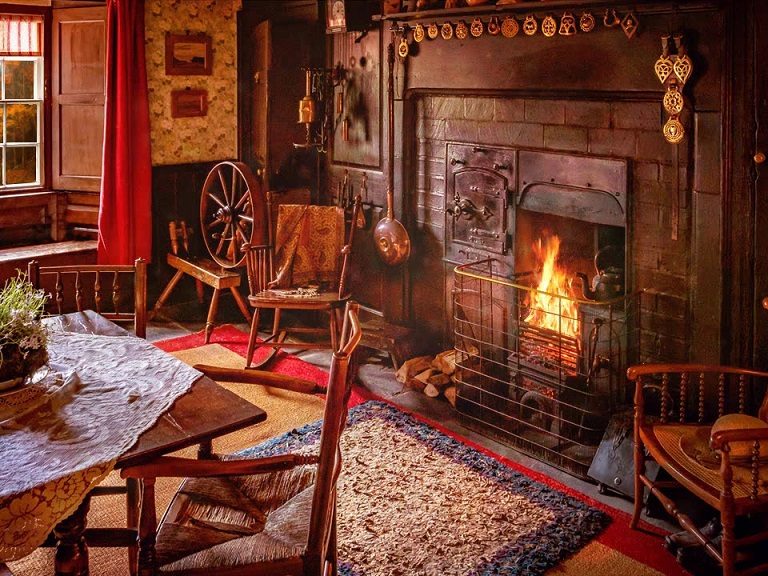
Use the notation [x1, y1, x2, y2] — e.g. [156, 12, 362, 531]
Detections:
[27, 258, 147, 338]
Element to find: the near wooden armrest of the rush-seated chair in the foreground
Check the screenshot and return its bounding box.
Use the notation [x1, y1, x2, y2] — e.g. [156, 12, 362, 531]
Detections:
[120, 454, 317, 478]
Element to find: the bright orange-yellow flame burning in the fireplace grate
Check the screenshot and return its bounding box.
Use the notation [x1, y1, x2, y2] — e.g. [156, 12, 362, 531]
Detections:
[525, 236, 579, 338]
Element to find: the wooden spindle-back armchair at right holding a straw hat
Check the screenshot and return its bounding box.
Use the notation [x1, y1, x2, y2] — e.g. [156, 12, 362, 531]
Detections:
[627, 364, 768, 576]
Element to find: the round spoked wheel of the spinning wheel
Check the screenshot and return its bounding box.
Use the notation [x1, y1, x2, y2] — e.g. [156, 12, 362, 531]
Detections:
[200, 162, 265, 268]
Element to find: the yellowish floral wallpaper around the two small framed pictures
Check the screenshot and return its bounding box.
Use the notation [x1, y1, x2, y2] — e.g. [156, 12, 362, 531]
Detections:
[145, 0, 240, 166]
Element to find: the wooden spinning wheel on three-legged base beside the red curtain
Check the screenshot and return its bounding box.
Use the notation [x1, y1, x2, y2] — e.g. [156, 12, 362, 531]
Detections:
[152, 162, 267, 343]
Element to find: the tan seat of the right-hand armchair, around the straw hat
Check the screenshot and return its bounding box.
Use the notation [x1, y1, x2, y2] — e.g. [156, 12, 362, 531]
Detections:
[640, 424, 768, 510]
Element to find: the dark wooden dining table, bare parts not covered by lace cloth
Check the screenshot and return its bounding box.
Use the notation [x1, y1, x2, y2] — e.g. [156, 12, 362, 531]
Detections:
[30, 311, 267, 576]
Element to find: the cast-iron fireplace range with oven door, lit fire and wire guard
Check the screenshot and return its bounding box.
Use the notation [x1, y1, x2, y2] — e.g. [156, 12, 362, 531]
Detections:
[444, 142, 639, 476]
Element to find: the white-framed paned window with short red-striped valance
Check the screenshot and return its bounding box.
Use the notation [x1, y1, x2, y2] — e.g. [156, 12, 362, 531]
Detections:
[0, 14, 44, 191]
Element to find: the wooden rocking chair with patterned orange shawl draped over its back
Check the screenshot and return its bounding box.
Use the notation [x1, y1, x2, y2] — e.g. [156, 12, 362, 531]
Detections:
[243, 195, 361, 367]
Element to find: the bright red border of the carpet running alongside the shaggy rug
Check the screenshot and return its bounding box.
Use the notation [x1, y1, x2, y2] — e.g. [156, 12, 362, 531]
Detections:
[154, 324, 689, 576]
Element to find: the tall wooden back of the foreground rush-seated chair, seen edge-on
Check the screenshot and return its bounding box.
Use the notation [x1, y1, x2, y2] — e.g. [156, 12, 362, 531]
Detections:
[307, 302, 362, 574]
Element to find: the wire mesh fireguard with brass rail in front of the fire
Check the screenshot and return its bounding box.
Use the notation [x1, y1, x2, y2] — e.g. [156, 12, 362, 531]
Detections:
[453, 259, 640, 478]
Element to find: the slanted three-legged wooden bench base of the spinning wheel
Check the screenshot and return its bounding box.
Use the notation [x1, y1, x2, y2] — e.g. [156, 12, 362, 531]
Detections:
[150, 220, 251, 344]
